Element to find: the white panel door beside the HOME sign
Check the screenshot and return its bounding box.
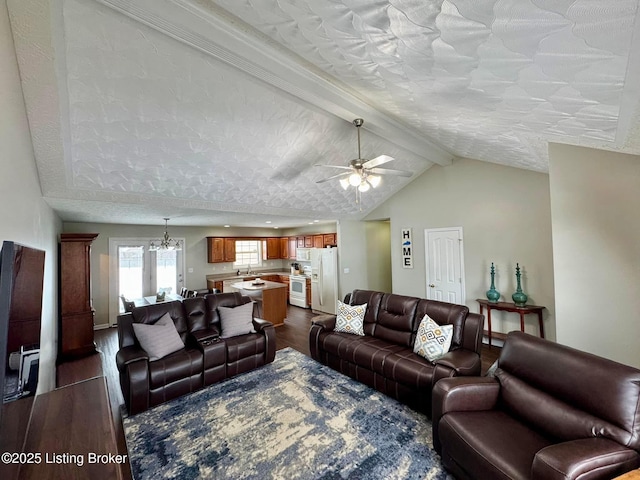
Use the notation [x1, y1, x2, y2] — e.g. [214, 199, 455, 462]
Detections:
[424, 227, 465, 305]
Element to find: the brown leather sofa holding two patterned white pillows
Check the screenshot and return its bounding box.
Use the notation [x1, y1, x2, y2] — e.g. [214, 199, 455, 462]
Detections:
[309, 290, 484, 415]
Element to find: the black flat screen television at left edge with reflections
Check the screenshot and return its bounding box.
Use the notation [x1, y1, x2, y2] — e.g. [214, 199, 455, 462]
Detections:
[0, 241, 45, 451]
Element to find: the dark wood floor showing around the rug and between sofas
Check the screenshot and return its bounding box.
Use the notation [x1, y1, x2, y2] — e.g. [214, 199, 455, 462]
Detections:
[95, 306, 500, 480]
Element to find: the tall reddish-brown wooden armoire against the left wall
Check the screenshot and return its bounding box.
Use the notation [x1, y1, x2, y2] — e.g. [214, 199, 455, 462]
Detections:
[58, 233, 98, 361]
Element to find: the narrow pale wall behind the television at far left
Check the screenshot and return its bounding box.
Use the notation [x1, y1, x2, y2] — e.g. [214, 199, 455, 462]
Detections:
[0, 0, 62, 392]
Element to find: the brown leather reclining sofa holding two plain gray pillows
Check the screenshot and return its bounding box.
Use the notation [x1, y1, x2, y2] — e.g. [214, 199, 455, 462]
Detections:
[116, 292, 276, 414]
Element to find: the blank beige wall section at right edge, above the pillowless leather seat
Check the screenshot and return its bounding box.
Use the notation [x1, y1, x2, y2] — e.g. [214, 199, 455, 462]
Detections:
[549, 144, 640, 367]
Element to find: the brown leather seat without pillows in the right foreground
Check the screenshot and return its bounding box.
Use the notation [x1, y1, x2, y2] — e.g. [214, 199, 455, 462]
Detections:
[433, 332, 640, 480]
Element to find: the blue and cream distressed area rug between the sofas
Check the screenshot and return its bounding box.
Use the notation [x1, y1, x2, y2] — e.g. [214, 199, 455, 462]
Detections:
[123, 348, 452, 480]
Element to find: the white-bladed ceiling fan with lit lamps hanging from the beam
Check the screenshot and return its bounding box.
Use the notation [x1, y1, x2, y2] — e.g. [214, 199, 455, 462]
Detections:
[316, 118, 413, 195]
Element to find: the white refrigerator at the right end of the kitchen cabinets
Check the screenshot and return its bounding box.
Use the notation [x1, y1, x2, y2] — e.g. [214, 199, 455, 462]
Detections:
[311, 248, 338, 315]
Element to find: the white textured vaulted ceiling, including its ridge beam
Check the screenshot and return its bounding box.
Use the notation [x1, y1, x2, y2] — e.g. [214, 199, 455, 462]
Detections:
[8, 0, 640, 227]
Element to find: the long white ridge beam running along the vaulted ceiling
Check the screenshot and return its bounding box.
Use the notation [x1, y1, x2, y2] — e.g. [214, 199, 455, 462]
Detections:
[96, 0, 453, 165]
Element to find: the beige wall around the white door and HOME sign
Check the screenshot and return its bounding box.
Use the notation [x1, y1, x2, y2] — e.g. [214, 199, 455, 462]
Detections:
[359, 159, 555, 339]
